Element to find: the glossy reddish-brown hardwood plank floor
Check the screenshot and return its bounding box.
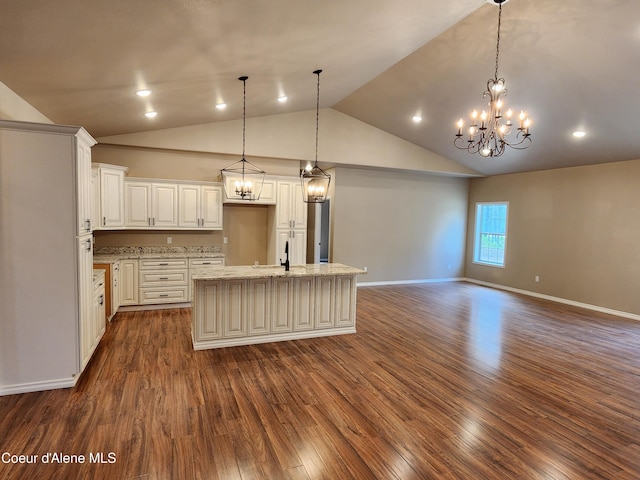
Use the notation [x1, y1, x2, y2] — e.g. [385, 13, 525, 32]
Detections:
[0, 283, 640, 480]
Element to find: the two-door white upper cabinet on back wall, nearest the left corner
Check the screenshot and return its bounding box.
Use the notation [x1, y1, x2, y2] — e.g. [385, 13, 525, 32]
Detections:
[124, 179, 178, 229]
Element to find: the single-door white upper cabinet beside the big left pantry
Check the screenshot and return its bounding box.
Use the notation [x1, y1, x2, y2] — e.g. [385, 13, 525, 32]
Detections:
[92, 163, 129, 230]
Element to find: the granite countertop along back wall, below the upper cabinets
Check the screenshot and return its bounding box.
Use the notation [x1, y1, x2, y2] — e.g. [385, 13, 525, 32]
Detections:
[93, 246, 224, 263]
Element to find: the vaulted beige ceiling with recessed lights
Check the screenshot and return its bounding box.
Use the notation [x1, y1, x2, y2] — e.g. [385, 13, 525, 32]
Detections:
[0, 0, 640, 174]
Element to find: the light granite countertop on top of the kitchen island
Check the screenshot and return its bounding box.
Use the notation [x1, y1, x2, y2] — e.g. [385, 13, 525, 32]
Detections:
[193, 263, 366, 281]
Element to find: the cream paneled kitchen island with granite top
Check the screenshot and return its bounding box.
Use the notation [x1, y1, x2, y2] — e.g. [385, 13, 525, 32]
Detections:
[191, 263, 365, 350]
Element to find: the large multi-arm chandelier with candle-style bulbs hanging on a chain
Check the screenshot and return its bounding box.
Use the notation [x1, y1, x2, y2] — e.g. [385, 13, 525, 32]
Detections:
[453, 0, 531, 157]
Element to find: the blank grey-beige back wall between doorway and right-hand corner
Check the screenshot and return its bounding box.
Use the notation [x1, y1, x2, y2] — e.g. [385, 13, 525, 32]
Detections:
[331, 168, 468, 283]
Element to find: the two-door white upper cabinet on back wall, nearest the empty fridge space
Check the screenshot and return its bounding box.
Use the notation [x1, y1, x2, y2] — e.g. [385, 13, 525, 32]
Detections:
[178, 184, 224, 230]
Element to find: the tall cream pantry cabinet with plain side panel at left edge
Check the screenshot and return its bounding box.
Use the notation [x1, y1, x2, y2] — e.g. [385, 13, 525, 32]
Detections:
[0, 121, 96, 395]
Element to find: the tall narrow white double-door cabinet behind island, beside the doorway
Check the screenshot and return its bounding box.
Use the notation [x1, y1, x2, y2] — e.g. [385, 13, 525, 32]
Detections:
[274, 179, 307, 265]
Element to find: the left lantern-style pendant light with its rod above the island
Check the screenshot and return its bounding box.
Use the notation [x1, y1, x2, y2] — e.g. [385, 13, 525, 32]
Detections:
[220, 76, 266, 201]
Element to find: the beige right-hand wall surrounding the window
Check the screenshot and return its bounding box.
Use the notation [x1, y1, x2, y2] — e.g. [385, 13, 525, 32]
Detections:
[465, 160, 640, 314]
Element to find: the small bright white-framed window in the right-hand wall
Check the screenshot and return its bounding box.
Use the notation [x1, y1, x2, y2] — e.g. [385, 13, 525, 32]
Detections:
[473, 202, 509, 267]
